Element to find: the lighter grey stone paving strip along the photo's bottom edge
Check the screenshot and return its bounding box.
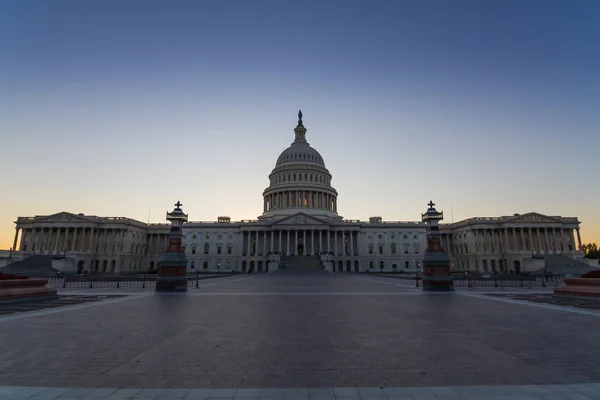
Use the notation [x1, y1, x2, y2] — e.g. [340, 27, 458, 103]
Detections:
[0, 383, 600, 400]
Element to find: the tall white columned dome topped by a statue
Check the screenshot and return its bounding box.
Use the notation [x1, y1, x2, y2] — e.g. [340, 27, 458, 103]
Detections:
[259, 111, 341, 219]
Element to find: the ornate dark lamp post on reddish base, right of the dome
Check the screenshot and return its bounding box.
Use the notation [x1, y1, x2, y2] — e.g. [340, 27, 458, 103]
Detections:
[421, 201, 454, 291]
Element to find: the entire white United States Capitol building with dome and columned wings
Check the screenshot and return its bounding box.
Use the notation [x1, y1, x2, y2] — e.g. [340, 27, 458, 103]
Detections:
[4, 112, 583, 273]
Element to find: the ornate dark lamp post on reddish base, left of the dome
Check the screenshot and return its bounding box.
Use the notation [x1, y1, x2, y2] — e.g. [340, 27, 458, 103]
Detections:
[156, 201, 187, 292]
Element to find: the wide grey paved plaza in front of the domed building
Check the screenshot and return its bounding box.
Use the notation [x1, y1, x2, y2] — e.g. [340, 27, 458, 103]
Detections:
[0, 274, 600, 400]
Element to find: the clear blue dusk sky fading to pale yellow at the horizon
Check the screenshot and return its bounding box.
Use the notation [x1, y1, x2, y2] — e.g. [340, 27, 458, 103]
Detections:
[0, 0, 600, 249]
